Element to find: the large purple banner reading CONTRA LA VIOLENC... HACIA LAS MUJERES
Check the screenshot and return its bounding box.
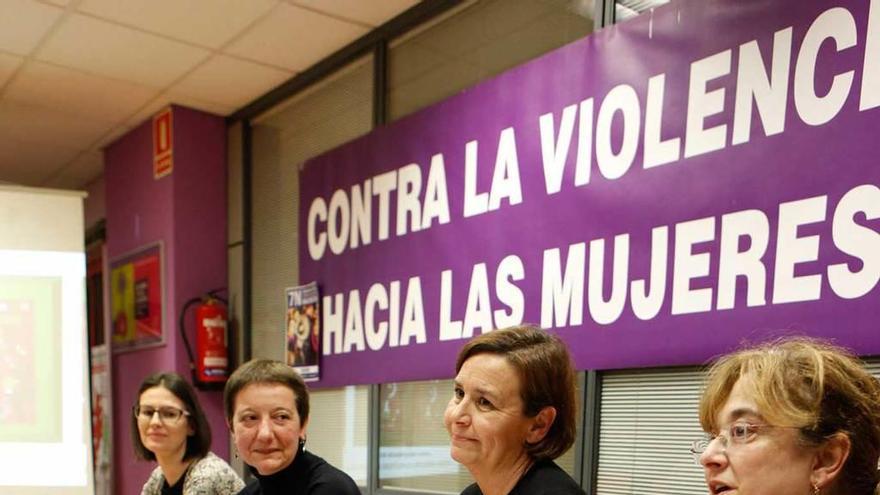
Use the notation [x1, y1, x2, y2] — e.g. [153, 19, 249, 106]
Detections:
[300, 0, 880, 386]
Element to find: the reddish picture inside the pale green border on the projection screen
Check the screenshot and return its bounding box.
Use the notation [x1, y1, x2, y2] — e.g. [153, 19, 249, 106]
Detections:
[0, 299, 37, 424]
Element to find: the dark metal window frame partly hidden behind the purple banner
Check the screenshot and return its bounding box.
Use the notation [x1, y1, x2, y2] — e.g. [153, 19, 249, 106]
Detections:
[226, 0, 636, 495]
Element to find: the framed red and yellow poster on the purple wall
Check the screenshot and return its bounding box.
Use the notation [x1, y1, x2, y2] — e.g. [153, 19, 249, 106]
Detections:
[110, 243, 165, 352]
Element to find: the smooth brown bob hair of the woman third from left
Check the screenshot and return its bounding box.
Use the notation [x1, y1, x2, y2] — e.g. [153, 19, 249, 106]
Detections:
[455, 325, 577, 461]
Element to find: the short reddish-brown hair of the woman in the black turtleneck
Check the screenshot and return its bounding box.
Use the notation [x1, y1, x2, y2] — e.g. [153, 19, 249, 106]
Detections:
[223, 359, 309, 427]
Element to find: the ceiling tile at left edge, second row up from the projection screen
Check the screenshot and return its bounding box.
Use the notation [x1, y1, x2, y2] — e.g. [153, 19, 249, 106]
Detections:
[0, 99, 111, 149]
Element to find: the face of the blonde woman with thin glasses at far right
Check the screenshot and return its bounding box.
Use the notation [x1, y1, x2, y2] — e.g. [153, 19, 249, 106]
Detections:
[700, 377, 813, 495]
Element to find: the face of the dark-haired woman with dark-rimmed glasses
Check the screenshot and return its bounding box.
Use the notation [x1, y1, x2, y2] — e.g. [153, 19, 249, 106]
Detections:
[137, 386, 194, 459]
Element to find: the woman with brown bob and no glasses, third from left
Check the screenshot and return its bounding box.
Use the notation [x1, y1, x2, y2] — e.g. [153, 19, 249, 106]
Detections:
[444, 326, 584, 495]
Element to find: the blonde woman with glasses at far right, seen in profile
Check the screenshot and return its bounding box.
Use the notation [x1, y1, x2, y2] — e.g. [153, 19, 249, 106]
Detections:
[692, 338, 880, 495]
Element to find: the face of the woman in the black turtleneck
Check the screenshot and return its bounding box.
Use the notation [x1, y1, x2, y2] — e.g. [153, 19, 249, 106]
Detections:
[230, 383, 306, 475]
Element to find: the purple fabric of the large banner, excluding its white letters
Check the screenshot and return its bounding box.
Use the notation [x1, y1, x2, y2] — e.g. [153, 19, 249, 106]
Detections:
[299, 0, 880, 387]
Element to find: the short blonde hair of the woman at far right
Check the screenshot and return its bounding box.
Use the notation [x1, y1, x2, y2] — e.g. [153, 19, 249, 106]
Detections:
[700, 337, 880, 495]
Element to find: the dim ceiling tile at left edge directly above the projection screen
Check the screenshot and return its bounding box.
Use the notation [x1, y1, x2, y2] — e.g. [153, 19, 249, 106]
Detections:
[0, 132, 79, 186]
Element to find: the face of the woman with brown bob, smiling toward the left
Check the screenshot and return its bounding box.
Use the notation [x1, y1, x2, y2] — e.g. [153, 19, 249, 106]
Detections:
[444, 354, 534, 474]
